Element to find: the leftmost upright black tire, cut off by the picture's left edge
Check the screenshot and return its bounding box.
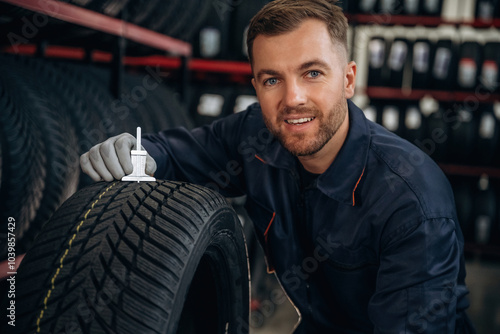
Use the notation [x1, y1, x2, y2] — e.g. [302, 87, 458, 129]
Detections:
[0, 62, 46, 260]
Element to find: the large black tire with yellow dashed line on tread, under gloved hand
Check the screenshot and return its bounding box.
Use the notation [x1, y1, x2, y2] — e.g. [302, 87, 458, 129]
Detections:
[6, 181, 249, 334]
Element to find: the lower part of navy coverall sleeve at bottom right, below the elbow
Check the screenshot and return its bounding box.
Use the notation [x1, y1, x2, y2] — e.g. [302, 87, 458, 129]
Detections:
[369, 217, 467, 334]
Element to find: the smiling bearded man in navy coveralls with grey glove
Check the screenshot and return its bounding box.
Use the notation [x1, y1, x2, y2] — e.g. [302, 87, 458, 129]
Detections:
[81, 0, 473, 334]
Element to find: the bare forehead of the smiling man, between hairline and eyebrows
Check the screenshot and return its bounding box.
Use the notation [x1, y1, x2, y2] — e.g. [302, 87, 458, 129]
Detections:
[252, 19, 342, 72]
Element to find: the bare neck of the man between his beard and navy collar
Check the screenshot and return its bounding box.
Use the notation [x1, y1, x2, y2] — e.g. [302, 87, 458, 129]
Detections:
[298, 112, 349, 174]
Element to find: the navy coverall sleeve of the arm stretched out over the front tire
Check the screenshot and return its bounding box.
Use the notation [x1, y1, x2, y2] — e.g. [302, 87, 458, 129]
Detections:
[143, 112, 250, 197]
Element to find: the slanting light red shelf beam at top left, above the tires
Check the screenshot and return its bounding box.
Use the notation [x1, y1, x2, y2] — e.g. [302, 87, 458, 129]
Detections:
[0, 0, 192, 56]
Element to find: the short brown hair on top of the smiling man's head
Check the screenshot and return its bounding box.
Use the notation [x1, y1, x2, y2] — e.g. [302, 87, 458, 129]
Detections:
[247, 0, 348, 63]
